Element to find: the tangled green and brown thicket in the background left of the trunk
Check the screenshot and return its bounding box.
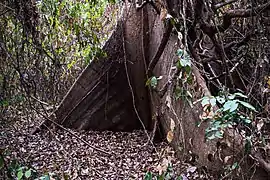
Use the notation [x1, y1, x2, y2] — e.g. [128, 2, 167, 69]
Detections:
[0, 0, 108, 114]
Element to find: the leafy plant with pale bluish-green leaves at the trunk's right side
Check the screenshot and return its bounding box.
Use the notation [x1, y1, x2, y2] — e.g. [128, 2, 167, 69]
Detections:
[200, 92, 256, 140]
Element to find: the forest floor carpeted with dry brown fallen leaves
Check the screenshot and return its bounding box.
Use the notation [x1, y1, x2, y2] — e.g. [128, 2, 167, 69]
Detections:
[0, 117, 209, 179]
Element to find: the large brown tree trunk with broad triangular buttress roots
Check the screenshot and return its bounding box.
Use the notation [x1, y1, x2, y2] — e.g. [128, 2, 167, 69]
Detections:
[36, 0, 270, 179]
